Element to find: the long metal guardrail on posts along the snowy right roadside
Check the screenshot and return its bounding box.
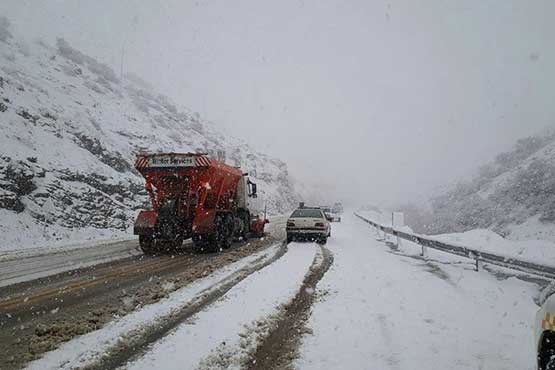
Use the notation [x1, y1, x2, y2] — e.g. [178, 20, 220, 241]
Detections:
[355, 213, 555, 279]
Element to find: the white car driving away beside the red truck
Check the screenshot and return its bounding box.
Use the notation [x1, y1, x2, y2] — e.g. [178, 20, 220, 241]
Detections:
[285, 208, 331, 244]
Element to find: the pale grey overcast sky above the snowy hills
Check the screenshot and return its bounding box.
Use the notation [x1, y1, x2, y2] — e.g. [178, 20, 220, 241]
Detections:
[0, 0, 555, 202]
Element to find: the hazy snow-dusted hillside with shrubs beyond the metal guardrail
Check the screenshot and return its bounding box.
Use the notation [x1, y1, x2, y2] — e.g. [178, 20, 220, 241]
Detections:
[405, 131, 555, 241]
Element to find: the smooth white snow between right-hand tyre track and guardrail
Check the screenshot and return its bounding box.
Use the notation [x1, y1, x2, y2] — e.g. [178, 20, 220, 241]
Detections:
[296, 215, 538, 370]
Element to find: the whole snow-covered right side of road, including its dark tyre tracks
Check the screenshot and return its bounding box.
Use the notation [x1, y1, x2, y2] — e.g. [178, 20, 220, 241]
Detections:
[6, 215, 538, 370]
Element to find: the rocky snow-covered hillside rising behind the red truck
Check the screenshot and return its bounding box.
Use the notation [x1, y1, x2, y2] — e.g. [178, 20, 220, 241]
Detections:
[0, 19, 298, 249]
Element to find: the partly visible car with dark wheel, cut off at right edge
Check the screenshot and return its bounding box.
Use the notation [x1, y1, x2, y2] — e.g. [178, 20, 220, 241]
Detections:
[534, 283, 555, 370]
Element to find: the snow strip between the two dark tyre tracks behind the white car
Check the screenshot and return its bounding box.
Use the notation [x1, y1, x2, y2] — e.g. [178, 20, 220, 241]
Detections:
[127, 243, 318, 370]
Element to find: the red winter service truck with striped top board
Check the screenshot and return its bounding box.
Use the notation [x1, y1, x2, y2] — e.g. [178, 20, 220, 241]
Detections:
[134, 153, 268, 254]
